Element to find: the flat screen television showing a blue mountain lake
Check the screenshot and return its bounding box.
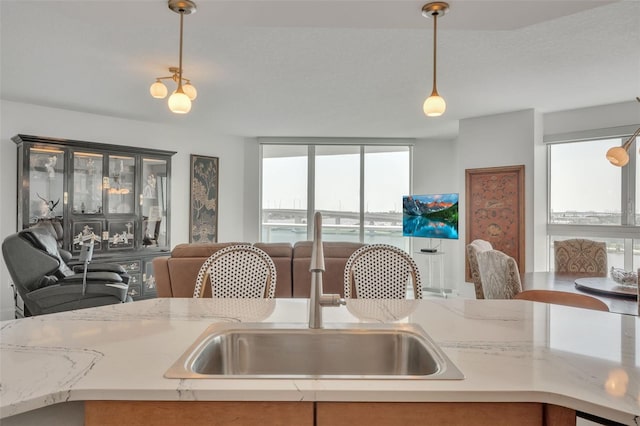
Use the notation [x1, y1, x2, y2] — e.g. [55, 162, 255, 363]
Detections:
[402, 194, 459, 240]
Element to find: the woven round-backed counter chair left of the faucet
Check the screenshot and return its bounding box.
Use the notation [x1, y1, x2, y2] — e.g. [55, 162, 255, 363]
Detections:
[193, 244, 277, 299]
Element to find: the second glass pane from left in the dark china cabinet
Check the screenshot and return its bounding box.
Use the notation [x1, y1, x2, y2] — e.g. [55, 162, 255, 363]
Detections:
[72, 152, 103, 214]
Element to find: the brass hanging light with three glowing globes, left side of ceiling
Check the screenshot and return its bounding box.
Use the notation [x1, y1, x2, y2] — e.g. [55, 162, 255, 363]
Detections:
[149, 0, 198, 114]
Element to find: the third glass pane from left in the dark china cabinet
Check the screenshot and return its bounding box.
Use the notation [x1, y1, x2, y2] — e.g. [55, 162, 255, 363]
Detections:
[107, 155, 136, 214]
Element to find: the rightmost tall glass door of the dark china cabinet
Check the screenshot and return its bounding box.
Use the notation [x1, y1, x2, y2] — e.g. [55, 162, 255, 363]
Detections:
[140, 158, 168, 246]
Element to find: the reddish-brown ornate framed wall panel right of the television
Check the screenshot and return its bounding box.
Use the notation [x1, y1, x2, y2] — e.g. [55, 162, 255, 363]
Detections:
[465, 165, 525, 282]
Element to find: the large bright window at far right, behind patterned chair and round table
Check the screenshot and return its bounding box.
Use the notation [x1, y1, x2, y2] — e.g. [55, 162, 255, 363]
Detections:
[547, 137, 640, 271]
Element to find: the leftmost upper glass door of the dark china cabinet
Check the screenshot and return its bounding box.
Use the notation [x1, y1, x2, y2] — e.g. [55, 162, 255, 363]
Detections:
[28, 147, 65, 223]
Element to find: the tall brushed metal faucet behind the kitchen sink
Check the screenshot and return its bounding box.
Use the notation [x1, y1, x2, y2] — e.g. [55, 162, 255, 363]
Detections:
[309, 212, 345, 328]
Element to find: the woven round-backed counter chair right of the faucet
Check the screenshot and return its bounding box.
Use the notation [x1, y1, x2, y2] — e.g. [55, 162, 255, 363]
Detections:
[344, 244, 422, 299]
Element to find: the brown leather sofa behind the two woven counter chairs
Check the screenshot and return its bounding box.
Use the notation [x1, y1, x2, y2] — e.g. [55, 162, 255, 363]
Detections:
[153, 241, 363, 297]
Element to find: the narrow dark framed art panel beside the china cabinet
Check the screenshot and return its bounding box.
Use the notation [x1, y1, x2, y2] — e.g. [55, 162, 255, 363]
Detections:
[189, 154, 219, 243]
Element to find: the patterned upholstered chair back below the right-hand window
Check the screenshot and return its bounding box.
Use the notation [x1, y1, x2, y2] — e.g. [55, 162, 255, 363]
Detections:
[553, 238, 609, 277]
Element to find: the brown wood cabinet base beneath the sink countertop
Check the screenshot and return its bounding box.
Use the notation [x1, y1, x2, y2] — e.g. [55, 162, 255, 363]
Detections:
[85, 401, 576, 426]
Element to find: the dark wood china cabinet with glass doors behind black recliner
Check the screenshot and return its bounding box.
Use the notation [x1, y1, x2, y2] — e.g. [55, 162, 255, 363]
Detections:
[12, 135, 175, 300]
